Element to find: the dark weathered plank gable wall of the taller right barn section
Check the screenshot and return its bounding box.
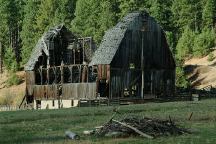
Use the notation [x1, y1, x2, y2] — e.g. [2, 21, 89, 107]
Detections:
[110, 14, 175, 98]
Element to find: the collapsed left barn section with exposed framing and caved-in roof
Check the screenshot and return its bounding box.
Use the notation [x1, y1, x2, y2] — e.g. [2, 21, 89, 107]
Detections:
[25, 25, 96, 108]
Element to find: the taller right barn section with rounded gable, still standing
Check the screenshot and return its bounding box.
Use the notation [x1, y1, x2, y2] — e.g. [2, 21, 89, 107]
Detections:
[90, 12, 175, 99]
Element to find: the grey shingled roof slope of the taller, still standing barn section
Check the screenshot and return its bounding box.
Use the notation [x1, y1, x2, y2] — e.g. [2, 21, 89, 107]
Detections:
[89, 12, 141, 66]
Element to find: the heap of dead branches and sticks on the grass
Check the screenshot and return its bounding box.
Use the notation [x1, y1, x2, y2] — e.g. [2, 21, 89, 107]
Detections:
[94, 117, 190, 139]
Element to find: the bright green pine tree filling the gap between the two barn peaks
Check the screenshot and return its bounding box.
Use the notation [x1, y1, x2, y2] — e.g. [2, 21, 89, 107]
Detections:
[71, 0, 116, 44]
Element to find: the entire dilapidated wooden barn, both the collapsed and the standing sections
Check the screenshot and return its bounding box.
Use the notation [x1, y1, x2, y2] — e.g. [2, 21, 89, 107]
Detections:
[25, 12, 175, 108]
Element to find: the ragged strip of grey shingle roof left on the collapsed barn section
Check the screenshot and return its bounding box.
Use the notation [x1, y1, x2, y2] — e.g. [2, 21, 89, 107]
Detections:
[24, 24, 73, 71]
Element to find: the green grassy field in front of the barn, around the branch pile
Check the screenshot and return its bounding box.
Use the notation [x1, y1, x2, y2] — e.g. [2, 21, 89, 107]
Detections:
[0, 99, 216, 144]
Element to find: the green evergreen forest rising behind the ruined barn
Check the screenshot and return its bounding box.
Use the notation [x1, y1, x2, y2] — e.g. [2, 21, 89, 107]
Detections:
[0, 0, 216, 86]
